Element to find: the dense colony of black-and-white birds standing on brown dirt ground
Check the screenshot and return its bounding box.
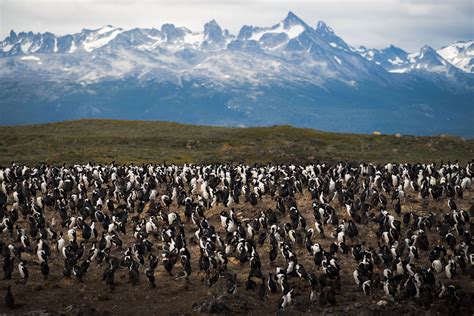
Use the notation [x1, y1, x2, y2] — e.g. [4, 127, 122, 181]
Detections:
[0, 160, 474, 311]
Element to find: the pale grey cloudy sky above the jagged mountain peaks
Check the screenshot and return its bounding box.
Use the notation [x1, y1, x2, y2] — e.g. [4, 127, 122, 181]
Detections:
[0, 0, 474, 51]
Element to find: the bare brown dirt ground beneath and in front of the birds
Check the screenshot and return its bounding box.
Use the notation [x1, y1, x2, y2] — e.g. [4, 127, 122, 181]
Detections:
[0, 184, 474, 315]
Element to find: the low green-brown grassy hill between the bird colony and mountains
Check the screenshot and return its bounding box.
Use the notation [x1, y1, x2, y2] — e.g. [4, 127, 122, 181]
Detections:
[0, 120, 474, 165]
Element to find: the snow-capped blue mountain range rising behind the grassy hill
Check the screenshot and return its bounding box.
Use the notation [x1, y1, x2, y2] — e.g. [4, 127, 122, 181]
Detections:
[0, 12, 474, 135]
